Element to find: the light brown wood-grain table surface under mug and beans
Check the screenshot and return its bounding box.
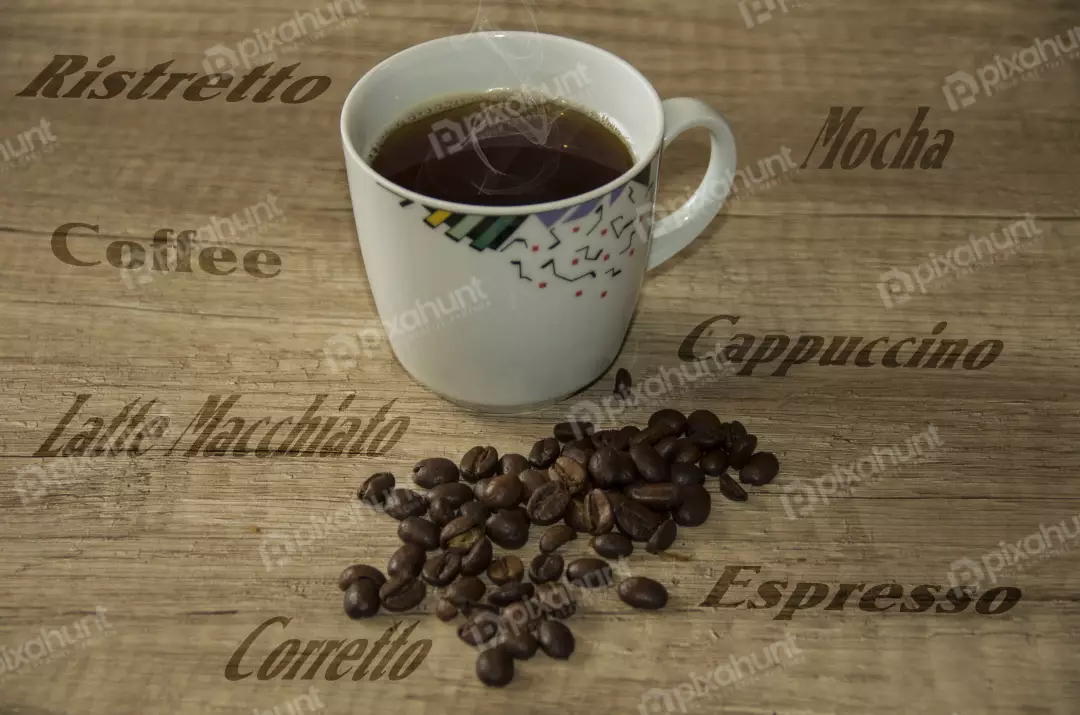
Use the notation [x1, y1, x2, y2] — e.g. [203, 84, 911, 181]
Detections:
[0, 0, 1080, 715]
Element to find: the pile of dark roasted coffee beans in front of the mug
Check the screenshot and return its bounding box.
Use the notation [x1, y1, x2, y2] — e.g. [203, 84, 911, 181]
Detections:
[338, 408, 780, 686]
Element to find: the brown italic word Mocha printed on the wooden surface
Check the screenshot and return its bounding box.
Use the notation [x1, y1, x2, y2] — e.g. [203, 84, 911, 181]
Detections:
[801, 107, 954, 170]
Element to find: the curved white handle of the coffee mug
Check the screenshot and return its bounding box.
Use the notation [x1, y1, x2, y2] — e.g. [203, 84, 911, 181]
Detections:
[646, 97, 735, 270]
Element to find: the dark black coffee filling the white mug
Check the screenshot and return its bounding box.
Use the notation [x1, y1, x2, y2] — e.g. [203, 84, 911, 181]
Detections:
[372, 91, 634, 206]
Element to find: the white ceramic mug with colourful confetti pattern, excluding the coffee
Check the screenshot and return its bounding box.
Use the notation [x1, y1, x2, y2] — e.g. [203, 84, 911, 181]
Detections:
[341, 31, 735, 413]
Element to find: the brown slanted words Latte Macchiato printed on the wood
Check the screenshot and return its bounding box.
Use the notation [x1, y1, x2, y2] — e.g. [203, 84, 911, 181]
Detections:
[33, 393, 409, 458]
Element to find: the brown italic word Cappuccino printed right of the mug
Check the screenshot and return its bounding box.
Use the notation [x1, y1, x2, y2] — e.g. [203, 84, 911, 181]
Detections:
[678, 315, 1004, 377]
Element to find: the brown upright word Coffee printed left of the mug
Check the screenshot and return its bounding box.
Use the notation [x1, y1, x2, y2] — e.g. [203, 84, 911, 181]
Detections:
[52, 222, 281, 278]
